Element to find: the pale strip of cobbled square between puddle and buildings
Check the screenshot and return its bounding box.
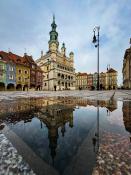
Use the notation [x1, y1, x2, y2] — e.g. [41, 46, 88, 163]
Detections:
[0, 90, 131, 101]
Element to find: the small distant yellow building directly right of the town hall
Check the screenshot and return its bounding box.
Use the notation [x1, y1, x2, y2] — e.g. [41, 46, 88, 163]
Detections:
[76, 72, 88, 89]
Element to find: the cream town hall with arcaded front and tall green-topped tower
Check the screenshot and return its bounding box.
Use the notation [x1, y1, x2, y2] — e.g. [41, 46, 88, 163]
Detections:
[36, 17, 75, 90]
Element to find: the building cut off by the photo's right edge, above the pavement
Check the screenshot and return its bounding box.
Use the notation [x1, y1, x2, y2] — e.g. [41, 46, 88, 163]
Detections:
[122, 42, 131, 89]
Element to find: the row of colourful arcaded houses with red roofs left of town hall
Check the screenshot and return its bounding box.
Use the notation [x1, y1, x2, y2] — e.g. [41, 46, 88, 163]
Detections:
[0, 51, 43, 90]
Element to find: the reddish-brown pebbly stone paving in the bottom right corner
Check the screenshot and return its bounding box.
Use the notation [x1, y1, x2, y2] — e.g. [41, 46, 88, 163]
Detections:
[93, 131, 131, 175]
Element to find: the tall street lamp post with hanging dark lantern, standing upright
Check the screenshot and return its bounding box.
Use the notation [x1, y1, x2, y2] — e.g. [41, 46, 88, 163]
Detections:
[92, 26, 100, 90]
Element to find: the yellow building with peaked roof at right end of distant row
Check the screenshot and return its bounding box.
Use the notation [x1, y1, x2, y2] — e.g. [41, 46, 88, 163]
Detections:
[106, 68, 117, 90]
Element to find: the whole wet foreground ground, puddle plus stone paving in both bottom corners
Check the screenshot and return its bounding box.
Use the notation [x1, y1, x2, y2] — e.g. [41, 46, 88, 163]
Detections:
[0, 95, 131, 175]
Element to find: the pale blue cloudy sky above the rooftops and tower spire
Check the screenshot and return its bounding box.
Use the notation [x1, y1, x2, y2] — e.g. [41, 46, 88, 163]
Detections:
[0, 0, 131, 84]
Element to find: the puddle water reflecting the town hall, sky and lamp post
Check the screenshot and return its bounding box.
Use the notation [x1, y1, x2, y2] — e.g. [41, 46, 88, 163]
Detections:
[0, 97, 131, 175]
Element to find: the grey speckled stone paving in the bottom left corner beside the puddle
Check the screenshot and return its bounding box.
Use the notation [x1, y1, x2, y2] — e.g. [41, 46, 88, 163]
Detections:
[0, 132, 35, 175]
